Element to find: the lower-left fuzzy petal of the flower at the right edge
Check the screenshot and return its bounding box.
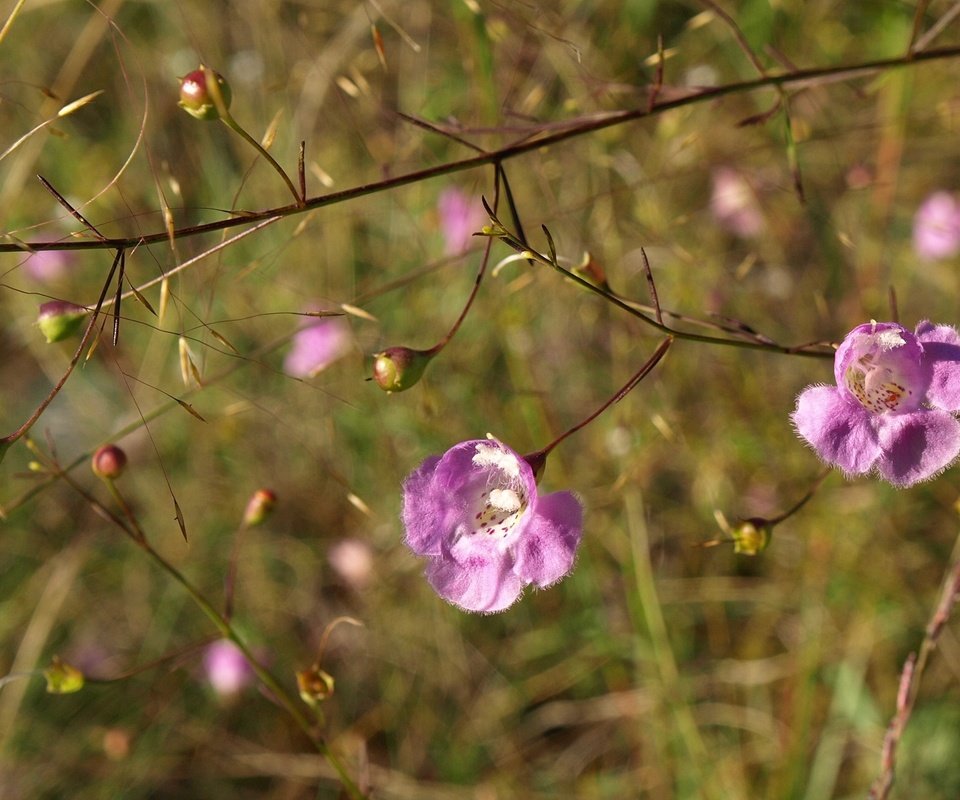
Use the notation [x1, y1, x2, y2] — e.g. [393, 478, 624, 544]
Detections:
[792, 386, 880, 475]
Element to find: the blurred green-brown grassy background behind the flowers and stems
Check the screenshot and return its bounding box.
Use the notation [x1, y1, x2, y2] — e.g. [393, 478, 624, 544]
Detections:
[0, 0, 960, 800]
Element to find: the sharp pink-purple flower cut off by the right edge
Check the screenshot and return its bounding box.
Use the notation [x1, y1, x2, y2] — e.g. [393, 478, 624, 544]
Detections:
[792, 322, 960, 487]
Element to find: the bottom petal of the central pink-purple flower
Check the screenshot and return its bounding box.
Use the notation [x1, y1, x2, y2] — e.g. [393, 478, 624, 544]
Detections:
[426, 553, 524, 614]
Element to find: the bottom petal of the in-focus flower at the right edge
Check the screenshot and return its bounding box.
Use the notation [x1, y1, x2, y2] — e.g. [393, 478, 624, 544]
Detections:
[877, 410, 960, 487]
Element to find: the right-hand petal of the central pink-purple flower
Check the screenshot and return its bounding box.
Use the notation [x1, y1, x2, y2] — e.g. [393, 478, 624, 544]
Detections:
[515, 492, 583, 588]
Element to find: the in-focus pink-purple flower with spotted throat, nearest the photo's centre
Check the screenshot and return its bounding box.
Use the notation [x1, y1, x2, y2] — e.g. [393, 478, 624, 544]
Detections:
[403, 439, 583, 613]
